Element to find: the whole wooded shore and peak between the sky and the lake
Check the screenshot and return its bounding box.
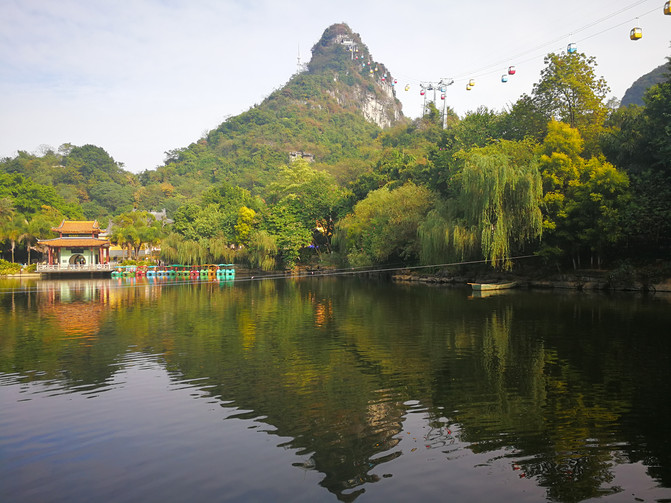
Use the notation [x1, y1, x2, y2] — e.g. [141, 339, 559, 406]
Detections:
[0, 25, 671, 270]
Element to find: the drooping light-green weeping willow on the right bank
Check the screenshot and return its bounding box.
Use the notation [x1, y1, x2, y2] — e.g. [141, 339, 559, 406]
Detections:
[419, 141, 543, 269]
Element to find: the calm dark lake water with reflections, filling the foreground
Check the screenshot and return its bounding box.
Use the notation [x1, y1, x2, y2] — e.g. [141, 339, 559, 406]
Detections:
[0, 277, 671, 503]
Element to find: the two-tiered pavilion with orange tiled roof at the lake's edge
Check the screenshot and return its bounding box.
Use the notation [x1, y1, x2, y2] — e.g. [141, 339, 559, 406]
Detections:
[38, 220, 110, 269]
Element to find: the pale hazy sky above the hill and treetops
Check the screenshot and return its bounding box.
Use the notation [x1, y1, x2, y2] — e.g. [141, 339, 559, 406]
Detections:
[0, 0, 671, 173]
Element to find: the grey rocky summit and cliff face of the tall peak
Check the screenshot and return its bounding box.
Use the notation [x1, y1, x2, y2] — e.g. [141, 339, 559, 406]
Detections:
[308, 24, 403, 128]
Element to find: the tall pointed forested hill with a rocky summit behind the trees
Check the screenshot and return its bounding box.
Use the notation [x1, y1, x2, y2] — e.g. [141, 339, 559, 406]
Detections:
[136, 24, 403, 206]
